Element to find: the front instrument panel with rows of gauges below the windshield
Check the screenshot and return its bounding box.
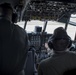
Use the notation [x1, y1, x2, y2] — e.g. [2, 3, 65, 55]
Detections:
[28, 32, 52, 50]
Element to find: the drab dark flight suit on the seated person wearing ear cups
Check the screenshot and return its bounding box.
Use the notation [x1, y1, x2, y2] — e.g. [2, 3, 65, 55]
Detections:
[38, 52, 76, 75]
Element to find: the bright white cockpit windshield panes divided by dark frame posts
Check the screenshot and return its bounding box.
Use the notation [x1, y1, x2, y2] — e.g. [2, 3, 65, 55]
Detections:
[17, 17, 76, 40]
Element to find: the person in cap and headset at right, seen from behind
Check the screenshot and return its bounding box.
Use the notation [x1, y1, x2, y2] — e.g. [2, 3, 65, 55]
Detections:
[38, 27, 76, 75]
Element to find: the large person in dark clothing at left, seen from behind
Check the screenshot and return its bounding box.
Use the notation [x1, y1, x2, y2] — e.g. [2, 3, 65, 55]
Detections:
[0, 3, 28, 75]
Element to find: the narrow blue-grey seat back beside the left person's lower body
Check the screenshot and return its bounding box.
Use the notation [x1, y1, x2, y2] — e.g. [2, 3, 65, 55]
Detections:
[25, 51, 34, 75]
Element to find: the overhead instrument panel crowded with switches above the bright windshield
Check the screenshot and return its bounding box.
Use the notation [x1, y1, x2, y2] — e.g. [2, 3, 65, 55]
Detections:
[22, 0, 76, 21]
